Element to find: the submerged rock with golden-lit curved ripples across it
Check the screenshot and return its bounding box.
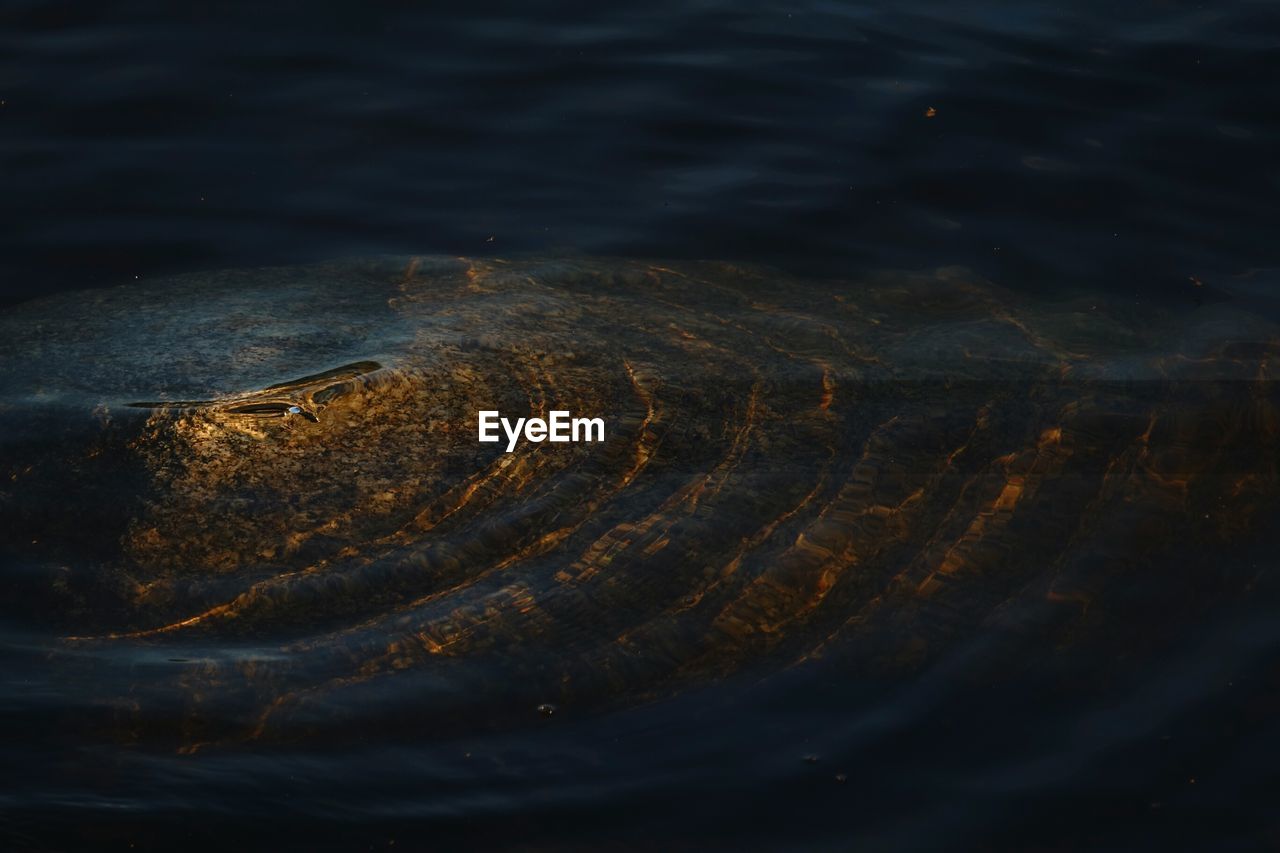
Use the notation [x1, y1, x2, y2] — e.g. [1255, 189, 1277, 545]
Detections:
[0, 259, 1280, 752]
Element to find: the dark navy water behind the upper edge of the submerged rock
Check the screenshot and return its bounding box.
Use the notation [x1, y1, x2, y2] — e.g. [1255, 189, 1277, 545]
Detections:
[0, 0, 1280, 306]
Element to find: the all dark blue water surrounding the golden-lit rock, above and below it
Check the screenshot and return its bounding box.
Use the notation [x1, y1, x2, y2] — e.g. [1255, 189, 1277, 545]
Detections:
[0, 0, 1280, 849]
